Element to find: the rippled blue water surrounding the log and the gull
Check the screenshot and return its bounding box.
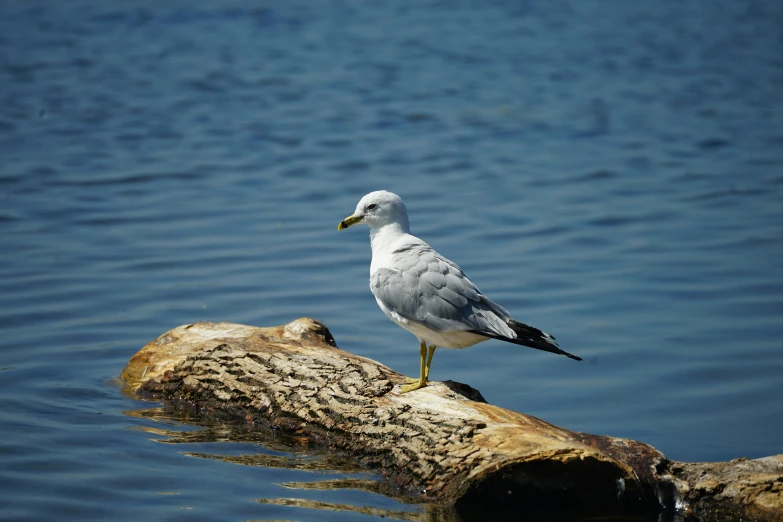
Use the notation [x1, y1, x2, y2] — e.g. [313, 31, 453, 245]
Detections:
[0, 0, 783, 521]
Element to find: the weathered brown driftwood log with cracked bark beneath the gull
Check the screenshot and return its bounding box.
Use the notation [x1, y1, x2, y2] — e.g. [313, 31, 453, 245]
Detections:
[122, 318, 783, 522]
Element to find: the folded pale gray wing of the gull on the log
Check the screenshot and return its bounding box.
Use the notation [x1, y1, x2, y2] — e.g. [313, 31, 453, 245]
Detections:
[370, 243, 514, 337]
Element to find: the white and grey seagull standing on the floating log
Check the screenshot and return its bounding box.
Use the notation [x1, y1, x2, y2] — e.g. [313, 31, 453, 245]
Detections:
[337, 190, 582, 393]
